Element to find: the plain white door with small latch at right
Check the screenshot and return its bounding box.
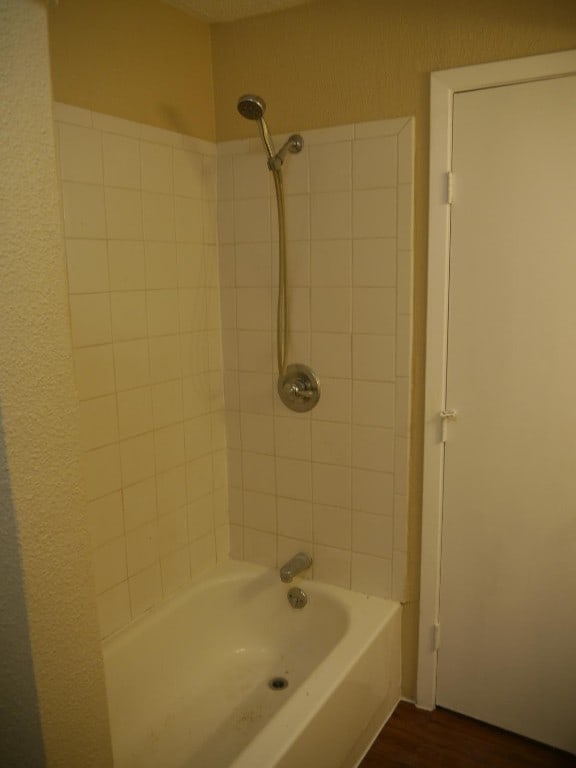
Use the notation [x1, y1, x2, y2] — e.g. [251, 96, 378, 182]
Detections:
[437, 76, 576, 752]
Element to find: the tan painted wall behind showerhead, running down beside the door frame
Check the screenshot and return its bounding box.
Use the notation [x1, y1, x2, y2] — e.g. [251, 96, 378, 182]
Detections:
[212, 0, 576, 697]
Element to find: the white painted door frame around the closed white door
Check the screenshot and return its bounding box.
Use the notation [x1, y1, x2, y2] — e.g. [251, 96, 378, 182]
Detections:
[416, 46, 576, 709]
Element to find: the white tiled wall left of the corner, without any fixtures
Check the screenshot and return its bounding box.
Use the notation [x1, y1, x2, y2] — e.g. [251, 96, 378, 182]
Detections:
[55, 104, 228, 637]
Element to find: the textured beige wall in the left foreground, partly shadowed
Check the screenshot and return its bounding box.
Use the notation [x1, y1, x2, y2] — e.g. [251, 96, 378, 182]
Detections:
[0, 0, 112, 768]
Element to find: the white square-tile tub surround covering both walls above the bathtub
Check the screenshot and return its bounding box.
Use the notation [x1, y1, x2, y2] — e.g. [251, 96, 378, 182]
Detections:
[55, 104, 413, 637]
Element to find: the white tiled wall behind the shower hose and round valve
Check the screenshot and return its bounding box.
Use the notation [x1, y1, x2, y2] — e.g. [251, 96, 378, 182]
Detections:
[218, 119, 413, 600]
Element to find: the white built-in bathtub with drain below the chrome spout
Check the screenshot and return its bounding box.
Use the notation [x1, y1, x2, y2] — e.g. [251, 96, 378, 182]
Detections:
[104, 562, 400, 768]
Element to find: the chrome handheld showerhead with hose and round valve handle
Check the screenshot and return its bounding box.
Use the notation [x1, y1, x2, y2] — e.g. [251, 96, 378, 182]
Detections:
[238, 93, 320, 411]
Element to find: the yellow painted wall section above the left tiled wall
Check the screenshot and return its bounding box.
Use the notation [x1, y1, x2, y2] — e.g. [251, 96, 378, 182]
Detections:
[49, 0, 214, 141]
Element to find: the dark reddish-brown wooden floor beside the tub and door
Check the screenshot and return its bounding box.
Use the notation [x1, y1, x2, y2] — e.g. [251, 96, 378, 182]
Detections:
[360, 701, 576, 768]
